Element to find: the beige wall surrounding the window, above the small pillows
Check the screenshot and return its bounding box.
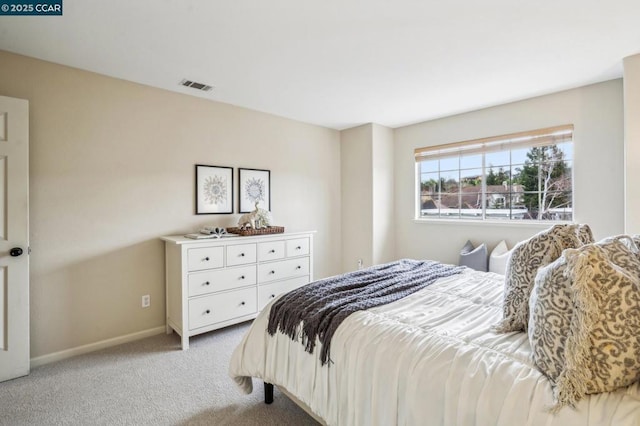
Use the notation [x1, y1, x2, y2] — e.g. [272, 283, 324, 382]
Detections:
[395, 80, 624, 263]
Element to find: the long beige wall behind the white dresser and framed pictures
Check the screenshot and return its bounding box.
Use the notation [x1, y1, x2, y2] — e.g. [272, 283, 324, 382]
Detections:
[0, 52, 341, 357]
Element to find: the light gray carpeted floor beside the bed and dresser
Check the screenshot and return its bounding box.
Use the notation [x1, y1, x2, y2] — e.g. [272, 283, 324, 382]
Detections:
[0, 323, 317, 426]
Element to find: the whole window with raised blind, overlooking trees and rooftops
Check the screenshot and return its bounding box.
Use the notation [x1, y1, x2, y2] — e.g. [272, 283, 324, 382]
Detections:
[415, 125, 573, 221]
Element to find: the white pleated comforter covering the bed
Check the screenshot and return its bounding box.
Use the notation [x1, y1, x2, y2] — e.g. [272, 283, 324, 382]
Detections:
[230, 270, 640, 426]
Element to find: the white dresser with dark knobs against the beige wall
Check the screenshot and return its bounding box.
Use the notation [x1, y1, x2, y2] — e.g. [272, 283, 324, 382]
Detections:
[162, 232, 313, 350]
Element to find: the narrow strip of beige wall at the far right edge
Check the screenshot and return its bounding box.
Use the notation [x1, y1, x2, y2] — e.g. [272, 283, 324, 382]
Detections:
[624, 55, 640, 234]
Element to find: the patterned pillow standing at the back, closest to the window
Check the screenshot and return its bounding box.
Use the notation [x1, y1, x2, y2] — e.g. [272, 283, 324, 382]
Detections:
[493, 224, 582, 333]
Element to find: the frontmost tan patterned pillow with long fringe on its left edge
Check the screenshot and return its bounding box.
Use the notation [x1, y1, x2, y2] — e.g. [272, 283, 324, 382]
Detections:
[554, 246, 640, 408]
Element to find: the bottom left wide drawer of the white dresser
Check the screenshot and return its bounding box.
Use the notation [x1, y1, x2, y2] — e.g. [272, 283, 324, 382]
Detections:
[189, 287, 257, 330]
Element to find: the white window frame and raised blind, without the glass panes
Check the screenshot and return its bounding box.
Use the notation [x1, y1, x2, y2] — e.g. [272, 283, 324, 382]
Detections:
[414, 124, 576, 226]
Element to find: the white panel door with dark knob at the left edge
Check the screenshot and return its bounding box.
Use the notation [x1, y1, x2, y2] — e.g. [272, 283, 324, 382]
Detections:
[0, 96, 30, 382]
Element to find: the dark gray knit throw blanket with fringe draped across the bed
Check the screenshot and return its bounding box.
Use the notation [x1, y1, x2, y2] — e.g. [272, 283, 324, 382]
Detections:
[267, 259, 464, 365]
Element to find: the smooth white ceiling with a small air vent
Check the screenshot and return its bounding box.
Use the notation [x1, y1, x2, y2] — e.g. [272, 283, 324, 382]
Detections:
[0, 0, 640, 129]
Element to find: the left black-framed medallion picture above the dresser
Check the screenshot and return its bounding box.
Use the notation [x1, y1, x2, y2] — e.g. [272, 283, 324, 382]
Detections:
[196, 164, 233, 214]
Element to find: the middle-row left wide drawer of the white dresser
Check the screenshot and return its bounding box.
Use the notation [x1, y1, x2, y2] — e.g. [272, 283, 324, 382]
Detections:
[189, 265, 256, 297]
